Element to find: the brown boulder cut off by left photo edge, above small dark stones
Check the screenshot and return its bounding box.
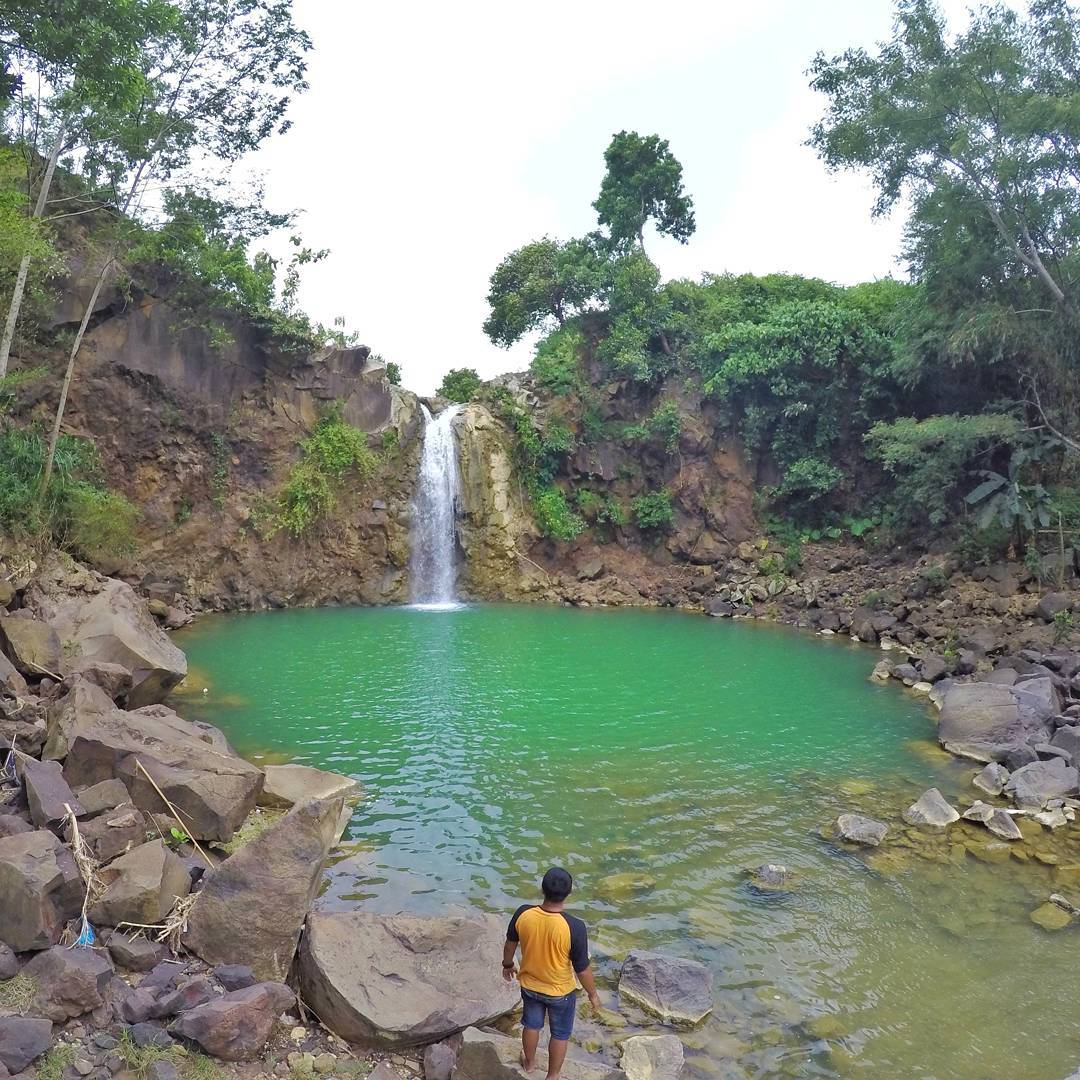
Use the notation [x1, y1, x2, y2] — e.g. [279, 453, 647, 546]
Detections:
[0, 829, 83, 953]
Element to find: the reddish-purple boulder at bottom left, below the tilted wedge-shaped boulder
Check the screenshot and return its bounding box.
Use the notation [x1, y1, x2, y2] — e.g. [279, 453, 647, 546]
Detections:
[168, 983, 296, 1062]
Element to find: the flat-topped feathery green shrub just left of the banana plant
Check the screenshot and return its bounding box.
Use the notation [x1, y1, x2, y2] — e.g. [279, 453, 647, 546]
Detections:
[866, 413, 1021, 526]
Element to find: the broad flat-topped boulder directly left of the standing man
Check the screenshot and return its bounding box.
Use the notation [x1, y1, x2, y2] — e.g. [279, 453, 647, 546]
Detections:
[299, 912, 519, 1047]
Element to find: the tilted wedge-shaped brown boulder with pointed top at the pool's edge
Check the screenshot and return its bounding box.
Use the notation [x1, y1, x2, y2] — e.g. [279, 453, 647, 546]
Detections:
[184, 796, 343, 982]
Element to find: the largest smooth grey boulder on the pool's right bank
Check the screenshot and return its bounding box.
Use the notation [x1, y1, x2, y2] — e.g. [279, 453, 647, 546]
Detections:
[937, 678, 1061, 761]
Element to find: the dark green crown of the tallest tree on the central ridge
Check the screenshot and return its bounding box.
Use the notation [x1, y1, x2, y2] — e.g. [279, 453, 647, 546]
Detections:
[593, 131, 696, 247]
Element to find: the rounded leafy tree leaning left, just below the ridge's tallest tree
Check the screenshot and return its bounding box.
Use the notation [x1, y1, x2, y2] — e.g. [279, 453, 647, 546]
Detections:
[484, 237, 604, 348]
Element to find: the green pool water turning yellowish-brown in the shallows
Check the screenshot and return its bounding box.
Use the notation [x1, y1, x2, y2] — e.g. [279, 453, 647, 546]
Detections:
[178, 606, 1080, 1080]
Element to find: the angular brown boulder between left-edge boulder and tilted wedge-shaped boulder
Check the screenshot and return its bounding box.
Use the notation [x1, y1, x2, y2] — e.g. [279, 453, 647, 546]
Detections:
[90, 840, 192, 927]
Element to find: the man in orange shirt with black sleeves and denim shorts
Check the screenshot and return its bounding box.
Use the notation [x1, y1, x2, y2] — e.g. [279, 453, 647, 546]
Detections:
[502, 866, 600, 1080]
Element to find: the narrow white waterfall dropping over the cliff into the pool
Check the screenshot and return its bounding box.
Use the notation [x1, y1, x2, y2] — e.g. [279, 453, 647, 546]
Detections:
[409, 405, 461, 610]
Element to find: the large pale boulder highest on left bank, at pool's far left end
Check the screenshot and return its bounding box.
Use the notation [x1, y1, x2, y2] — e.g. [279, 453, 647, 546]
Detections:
[37, 578, 188, 708]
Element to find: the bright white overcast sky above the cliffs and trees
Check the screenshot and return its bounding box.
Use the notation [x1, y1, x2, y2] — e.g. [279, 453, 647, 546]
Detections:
[254, 0, 980, 393]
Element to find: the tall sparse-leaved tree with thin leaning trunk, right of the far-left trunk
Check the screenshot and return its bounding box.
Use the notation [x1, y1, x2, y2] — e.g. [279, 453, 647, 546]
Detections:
[39, 0, 311, 499]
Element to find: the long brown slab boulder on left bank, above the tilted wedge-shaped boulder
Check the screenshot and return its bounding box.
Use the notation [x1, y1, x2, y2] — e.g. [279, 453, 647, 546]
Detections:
[64, 705, 262, 842]
